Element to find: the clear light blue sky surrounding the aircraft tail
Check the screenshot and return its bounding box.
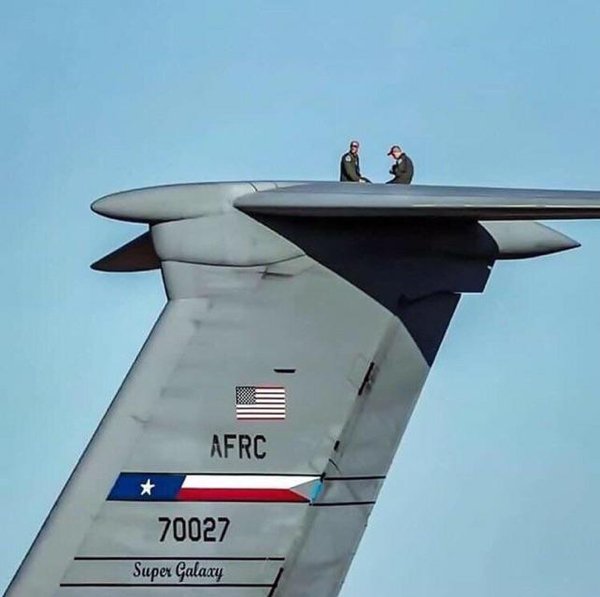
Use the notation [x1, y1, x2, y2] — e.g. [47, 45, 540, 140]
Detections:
[0, 0, 600, 597]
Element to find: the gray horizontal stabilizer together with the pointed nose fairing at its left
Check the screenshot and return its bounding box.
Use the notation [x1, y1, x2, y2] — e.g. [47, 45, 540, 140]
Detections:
[92, 182, 600, 223]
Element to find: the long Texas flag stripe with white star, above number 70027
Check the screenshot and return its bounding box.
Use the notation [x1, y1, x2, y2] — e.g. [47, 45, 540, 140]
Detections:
[107, 473, 321, 503]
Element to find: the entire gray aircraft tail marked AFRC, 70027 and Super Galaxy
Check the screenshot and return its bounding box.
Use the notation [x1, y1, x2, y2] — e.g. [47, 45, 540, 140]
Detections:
[8, 182, 600, 597]
